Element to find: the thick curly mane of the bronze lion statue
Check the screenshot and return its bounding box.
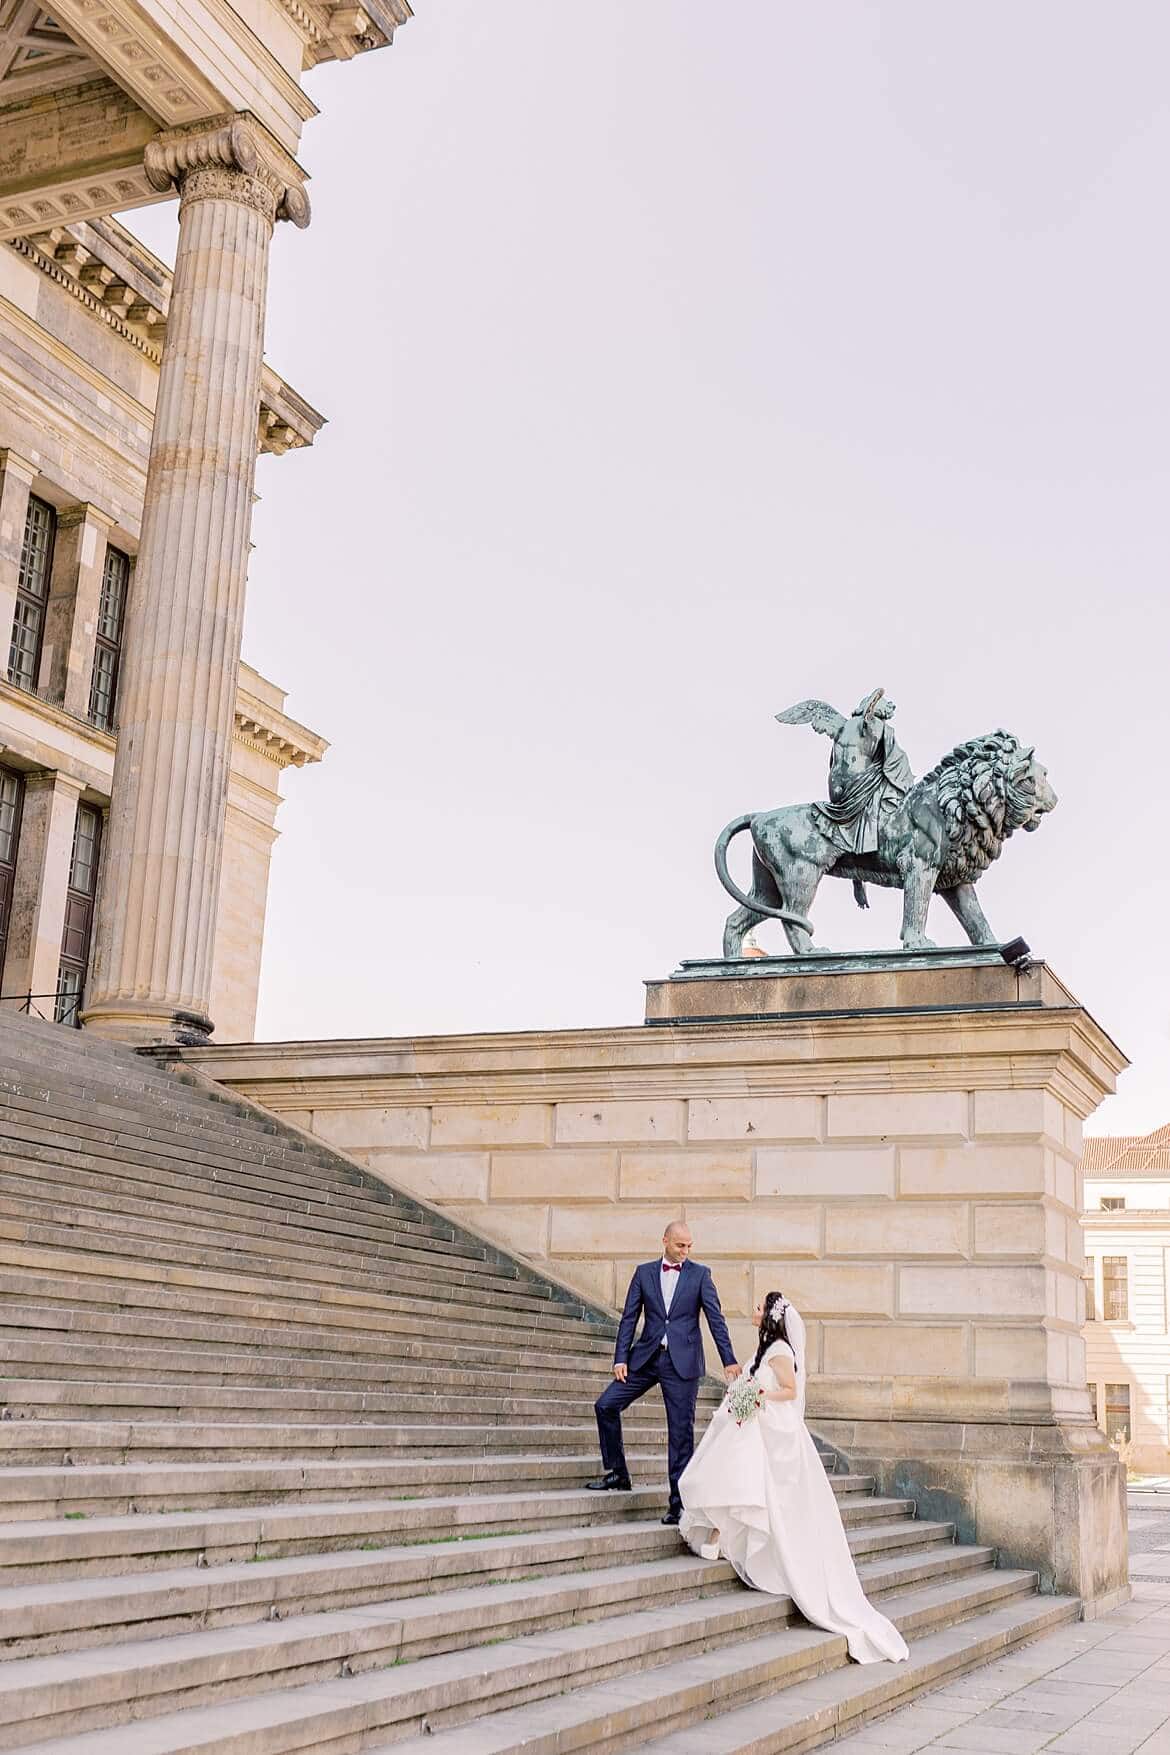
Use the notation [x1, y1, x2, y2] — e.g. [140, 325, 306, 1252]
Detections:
[919, 730, 1031, 890]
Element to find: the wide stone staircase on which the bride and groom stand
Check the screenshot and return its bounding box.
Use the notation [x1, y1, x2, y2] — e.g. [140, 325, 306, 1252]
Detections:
[0, 1013, 1079, 1755]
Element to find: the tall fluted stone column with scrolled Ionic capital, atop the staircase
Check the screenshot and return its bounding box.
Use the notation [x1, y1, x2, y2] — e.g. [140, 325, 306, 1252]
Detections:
[82, 116, 309, 1042]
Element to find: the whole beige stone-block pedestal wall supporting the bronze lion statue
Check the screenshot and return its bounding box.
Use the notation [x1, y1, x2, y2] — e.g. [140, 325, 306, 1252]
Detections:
[187, 951, 1126, 1609]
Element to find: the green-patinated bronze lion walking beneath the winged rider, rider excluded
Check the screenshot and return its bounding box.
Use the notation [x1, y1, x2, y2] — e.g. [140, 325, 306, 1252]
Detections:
[716, 732, 1056, 956]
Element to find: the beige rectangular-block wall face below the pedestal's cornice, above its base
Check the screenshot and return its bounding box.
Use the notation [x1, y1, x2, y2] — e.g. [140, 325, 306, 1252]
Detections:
[270, 1067, 1084, 1413]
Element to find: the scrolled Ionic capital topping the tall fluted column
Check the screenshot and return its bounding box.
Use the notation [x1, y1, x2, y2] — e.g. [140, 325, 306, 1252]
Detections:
[144, 112, 310, 230]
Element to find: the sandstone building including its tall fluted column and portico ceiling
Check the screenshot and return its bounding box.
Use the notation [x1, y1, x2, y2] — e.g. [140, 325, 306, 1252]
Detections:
[0, 0, 410, 1042]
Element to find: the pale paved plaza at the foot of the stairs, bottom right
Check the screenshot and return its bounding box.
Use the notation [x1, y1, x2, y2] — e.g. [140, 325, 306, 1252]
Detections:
[835, 1479, 1170, 1755]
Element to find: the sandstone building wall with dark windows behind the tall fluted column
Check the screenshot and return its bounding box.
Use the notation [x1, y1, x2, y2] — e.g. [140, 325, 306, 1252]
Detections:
[0, 219, 325, 1041]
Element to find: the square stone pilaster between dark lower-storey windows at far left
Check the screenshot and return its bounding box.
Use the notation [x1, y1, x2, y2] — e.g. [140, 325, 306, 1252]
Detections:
[4, 772, 82, 1018]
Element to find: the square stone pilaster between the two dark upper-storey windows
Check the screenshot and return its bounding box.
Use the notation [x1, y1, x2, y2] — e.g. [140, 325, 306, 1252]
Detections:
[40, 505, 114, 720]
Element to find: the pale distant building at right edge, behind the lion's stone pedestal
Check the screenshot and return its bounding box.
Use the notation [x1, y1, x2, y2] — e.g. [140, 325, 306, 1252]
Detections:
[1082, 1125, 1170, 1474]
